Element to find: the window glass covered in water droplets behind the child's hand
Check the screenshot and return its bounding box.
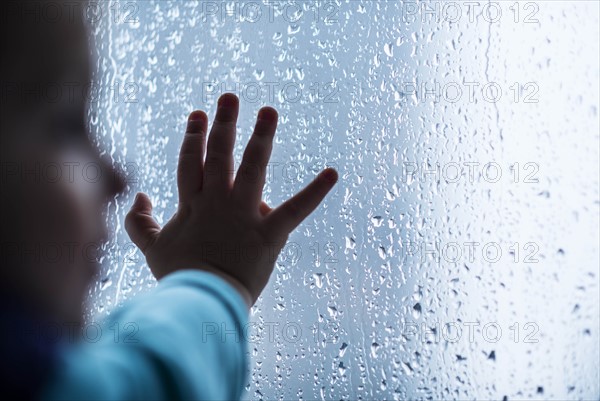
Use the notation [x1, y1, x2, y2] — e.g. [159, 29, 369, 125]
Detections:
[87, 1, 600, 400]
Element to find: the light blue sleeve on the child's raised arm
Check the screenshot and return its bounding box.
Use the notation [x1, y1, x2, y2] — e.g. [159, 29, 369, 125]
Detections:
[41, 270, 248, 400]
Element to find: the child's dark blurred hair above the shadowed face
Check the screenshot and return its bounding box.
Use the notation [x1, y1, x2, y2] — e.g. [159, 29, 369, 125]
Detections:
[0, 0, 89, 131]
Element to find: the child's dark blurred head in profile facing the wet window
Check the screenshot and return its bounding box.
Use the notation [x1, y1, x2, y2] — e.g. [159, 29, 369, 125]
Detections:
[0, 1, 124, 322]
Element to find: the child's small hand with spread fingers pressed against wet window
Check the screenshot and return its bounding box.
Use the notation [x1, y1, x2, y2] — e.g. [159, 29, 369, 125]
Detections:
[125, 94, 338, 305]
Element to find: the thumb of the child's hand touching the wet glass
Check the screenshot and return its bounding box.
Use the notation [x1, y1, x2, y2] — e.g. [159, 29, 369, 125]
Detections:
[125, 192, 160, 254]
